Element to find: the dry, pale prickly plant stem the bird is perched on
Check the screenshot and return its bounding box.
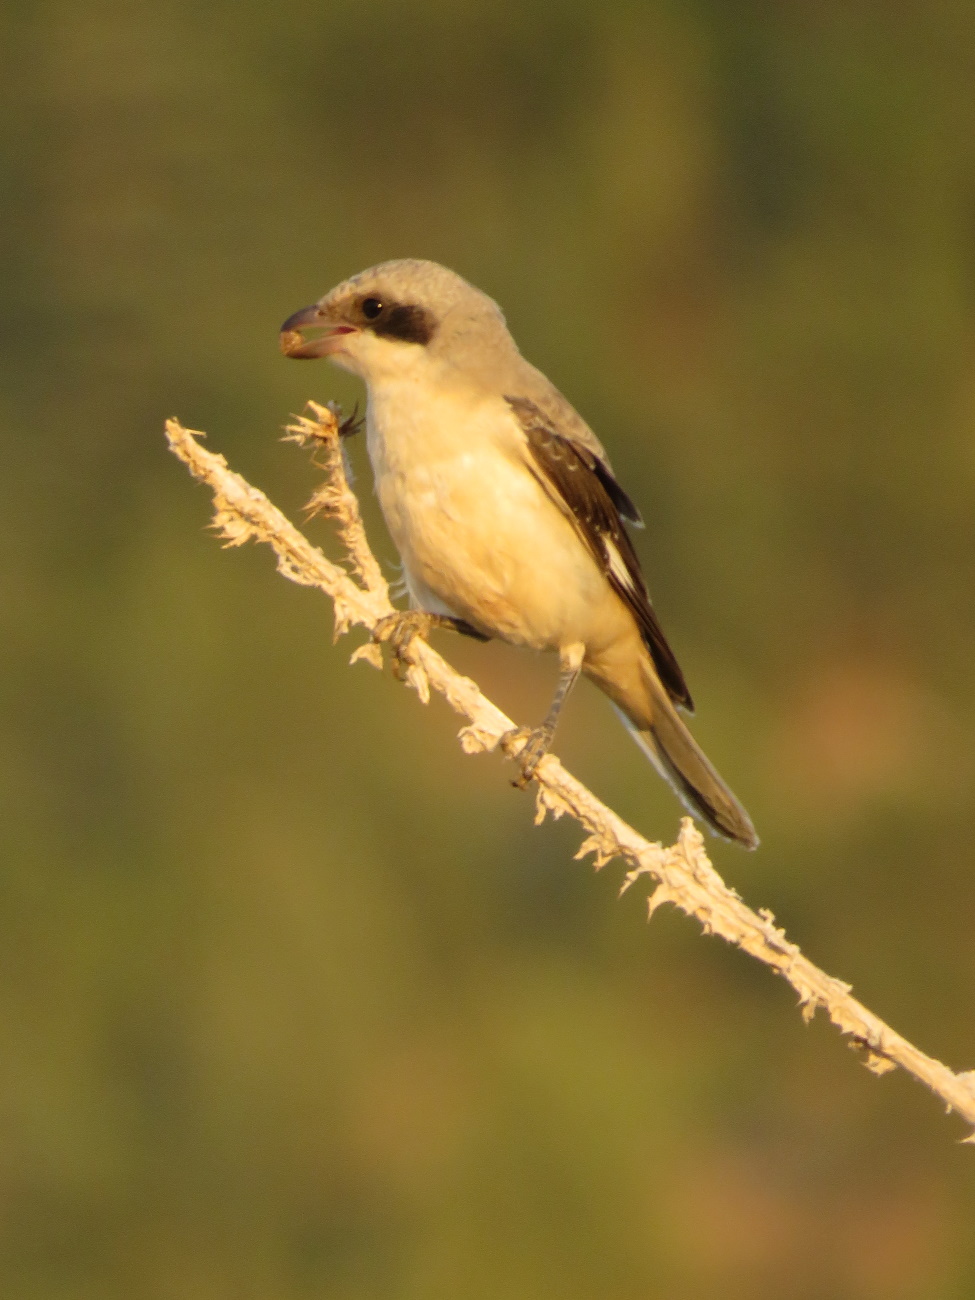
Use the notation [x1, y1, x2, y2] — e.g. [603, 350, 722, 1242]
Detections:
[166, 403, 975, 1143]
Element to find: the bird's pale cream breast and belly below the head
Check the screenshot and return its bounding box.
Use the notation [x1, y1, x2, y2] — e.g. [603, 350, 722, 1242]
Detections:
[369, 382, 611, 649]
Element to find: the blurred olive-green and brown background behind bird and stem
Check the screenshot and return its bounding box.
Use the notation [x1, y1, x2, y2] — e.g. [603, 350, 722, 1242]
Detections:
[0, 0, 975, 1300]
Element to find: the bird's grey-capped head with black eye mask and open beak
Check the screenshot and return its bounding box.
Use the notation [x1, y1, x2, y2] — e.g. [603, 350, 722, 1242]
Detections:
[281, 259, 517, 384]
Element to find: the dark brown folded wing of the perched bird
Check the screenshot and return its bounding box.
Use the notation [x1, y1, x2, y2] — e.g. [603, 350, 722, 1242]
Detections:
[504, 397, 694, 711]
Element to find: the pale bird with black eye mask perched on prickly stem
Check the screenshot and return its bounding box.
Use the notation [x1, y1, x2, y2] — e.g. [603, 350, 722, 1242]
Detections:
[280, 257, 758, 849]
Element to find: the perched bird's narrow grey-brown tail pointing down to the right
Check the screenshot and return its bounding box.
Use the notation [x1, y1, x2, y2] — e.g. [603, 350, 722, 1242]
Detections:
[619, 668, 758, 849]
